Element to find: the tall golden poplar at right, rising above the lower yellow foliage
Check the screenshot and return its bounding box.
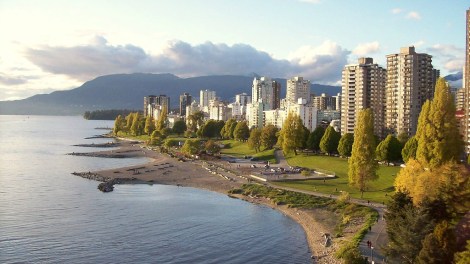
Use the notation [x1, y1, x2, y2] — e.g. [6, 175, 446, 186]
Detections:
[416, 78, 463, 169]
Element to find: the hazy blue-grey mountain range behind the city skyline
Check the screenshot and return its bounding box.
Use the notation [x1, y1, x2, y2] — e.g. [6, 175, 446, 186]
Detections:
[0, 73, 341, 115]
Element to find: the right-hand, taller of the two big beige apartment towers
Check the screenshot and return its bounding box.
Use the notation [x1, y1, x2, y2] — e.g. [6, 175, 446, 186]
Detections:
[386, 47, 439, 136]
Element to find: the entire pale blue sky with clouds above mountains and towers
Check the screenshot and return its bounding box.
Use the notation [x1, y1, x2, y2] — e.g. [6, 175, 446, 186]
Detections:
[0, 0, 470, 101]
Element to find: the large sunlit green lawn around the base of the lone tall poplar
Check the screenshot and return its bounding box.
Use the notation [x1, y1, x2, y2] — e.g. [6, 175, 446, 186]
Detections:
[275, 154, 400, 202]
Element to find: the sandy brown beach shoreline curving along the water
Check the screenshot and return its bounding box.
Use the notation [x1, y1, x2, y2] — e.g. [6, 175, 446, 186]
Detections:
[69, 138, 341, 263]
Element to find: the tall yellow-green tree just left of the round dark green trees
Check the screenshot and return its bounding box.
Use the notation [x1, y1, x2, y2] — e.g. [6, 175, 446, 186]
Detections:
[278, 112, 305, 155]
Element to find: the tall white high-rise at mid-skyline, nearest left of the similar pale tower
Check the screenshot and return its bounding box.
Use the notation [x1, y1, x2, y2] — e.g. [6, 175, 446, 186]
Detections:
[251, 77, 281, 110]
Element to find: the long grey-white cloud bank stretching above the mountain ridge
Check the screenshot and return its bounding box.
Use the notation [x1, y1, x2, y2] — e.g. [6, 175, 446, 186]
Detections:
[26, 36, 349, 83]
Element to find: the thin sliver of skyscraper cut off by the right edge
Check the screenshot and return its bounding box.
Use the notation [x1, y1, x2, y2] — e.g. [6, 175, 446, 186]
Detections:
[463, 9, 470, 153]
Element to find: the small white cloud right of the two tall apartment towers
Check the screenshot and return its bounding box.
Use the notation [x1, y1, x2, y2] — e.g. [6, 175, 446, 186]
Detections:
[427, 44, 465, 72]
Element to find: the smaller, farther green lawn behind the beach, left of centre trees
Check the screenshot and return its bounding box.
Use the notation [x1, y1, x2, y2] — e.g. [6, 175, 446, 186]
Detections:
[220, 140, 276, 163]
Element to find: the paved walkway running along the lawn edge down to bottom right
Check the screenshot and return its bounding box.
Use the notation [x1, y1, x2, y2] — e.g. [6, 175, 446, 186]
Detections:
[267, 150, 388, 263]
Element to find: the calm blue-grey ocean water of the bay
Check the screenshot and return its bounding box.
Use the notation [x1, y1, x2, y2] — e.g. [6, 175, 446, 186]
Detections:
[0, 115, 310, 263]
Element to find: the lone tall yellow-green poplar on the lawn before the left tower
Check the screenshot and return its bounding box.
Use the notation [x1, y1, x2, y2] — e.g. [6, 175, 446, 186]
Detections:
[348, 108, 378, 198]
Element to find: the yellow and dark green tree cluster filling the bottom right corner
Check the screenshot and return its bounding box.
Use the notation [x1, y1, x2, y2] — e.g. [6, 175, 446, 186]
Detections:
[386, 79, 470, 263]
